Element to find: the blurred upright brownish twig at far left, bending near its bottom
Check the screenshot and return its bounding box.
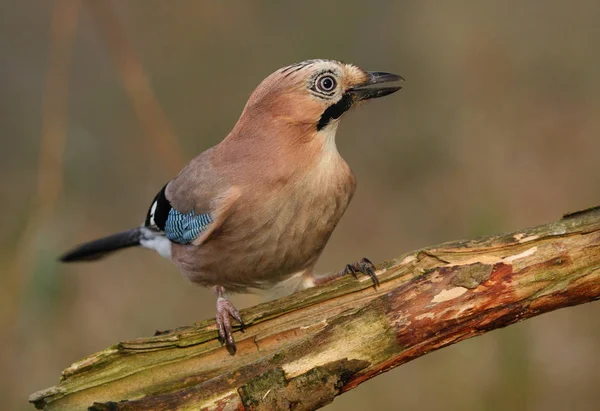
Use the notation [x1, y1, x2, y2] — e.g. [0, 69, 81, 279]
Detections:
[7, 0, 79, 326]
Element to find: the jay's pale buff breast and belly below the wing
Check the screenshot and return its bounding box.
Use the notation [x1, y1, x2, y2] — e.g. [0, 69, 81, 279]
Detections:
[176, 145, 356, 291]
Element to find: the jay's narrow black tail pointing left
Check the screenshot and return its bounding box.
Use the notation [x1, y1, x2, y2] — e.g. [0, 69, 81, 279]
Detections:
[60, 227, 143, 262]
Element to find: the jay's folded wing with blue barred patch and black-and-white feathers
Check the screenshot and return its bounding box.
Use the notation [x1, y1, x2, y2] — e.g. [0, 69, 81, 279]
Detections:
[145, 150, 240, 245]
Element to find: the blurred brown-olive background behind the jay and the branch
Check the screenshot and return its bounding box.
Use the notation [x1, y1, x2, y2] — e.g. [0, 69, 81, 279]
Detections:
[0, 0, 600, 411]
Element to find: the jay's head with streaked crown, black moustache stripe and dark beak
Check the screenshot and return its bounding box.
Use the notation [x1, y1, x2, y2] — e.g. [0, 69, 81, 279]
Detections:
[238, 60, 404, 131]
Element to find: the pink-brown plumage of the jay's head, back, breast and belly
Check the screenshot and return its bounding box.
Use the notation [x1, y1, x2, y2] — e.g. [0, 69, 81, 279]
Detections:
[167, 61, 367, 291]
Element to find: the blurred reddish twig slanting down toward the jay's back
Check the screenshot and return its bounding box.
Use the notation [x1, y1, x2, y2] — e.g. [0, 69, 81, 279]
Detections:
[85, 1, 185, 175]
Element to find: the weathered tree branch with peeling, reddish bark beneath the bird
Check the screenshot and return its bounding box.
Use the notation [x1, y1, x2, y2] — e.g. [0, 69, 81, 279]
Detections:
[30, 207, 600, 410]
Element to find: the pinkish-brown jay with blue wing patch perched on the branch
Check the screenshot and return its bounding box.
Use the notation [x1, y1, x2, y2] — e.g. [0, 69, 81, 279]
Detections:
[60, 59, 404, 355]
